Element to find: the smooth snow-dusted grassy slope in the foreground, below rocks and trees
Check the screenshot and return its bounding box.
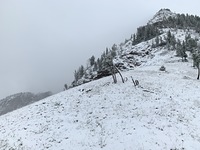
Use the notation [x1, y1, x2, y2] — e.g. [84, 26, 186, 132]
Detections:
[0, 50, 200, 150]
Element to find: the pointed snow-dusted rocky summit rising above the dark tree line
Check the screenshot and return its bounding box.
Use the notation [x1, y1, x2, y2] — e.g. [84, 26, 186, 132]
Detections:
[148, 9, 176, 24]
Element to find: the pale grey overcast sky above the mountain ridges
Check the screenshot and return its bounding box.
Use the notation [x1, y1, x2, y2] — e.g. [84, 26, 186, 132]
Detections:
[0, 0, 200, 98]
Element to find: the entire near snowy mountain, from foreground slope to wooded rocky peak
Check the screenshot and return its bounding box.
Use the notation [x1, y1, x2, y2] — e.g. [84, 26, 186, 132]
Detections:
[0, 10, 200, 150]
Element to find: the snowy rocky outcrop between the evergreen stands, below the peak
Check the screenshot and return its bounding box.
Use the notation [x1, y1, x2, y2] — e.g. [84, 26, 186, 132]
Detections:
[113, 28, 199, 70]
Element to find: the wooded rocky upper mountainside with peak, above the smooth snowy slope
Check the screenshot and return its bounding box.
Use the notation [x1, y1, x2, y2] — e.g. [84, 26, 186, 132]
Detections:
[70, 9, 200, 87]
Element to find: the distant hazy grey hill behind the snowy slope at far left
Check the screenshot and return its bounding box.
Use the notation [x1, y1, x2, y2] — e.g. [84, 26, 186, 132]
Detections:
[0, 92, 52, 115]
